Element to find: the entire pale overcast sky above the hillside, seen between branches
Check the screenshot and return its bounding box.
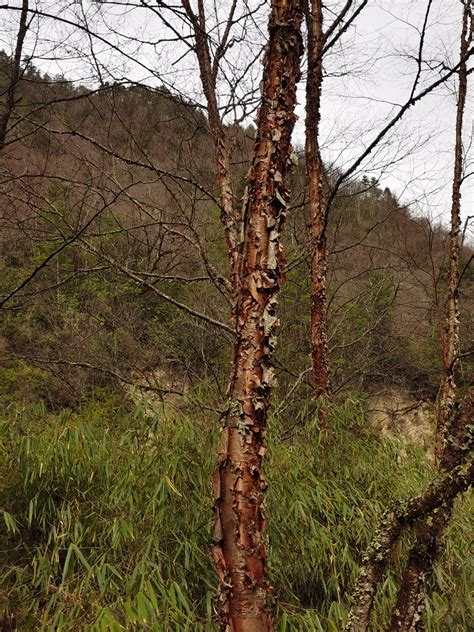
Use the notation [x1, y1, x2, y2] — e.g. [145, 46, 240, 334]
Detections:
[0, 0, 474, 239]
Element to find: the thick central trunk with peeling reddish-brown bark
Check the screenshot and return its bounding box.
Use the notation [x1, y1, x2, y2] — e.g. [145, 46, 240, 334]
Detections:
[213, 0, 302, 632]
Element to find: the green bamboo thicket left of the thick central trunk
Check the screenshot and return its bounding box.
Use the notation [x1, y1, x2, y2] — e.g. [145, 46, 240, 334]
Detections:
[2, 400, 213, 630]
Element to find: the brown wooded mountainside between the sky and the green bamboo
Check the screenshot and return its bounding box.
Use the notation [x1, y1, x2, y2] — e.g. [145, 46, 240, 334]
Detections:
[1, 65, 473, 416]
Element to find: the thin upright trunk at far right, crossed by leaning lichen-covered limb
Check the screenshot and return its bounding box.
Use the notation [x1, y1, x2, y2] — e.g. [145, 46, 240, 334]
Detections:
[389, 6, 473, 632]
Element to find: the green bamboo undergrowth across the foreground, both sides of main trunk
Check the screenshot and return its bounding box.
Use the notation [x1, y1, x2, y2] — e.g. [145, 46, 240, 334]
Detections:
[0, 392, 469, 632]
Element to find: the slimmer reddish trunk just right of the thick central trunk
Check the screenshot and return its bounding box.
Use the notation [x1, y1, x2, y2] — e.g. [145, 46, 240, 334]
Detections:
[305, 0, 329, 397]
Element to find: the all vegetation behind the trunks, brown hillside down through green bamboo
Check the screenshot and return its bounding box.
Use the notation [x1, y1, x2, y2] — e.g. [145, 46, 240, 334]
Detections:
[0, 1, 474, 632]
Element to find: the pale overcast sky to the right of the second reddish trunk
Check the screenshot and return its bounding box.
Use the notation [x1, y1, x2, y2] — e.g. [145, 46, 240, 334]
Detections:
[310, 0, 474, 234]
